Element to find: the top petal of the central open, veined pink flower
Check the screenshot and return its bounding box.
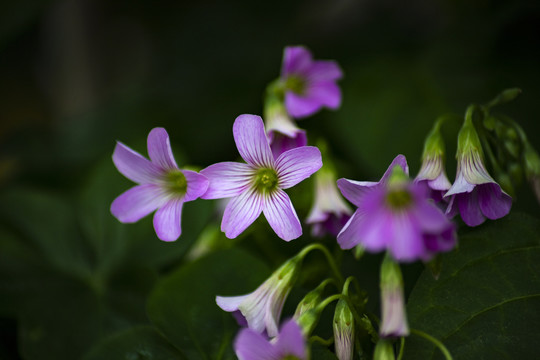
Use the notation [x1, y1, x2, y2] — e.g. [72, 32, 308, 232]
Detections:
[233, 114, 274, 167]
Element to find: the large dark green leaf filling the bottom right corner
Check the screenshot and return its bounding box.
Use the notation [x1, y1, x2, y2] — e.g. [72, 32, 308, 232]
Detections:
[405, 214, 540, 359]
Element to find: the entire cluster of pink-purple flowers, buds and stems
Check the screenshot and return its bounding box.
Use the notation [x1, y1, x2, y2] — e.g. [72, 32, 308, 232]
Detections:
[106, 46, 528, 360]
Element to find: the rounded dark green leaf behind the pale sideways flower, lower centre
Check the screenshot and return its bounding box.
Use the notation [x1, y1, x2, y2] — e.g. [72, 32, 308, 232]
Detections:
[148, 249, 270, 360]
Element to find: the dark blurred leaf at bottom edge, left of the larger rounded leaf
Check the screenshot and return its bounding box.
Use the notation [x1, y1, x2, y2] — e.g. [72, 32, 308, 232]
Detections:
[82, 326, 184, 360]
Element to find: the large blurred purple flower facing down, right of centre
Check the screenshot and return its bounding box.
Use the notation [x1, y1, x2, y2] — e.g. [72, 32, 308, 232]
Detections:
[337, 155, 456, 262]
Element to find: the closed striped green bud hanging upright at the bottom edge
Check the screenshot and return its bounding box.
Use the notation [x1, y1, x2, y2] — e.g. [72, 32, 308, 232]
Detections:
[333, 299, 354, 360]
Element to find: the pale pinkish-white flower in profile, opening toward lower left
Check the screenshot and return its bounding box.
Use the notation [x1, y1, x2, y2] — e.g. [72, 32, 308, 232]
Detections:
[216, 257, 301, 337]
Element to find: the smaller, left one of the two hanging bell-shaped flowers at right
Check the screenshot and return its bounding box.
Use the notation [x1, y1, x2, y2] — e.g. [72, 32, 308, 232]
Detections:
[415, 118, 452, 203]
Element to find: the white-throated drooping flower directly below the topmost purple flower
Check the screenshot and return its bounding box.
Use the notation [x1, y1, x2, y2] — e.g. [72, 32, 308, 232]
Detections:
[264, 91, 307, 158]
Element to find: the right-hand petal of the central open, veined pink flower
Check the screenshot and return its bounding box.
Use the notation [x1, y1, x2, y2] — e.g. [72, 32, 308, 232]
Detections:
[275, 146, 322, 189]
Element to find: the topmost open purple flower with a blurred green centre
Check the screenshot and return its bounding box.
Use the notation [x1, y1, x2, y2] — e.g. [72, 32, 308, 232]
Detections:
[281, 46, 343, 118]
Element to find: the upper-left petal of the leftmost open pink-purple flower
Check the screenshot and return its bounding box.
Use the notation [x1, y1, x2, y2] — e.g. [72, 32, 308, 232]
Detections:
[113, 141, 163, 184]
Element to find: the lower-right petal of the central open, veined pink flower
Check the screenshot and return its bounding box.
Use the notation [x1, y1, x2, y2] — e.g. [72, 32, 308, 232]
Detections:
[263, 189, 302, 241]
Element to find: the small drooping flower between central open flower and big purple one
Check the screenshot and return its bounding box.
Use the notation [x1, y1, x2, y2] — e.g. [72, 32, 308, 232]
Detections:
[306, 167, 352, 237]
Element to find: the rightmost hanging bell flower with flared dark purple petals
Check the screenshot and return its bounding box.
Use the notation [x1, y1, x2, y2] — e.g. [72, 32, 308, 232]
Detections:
[444, 110, 512, 226]
